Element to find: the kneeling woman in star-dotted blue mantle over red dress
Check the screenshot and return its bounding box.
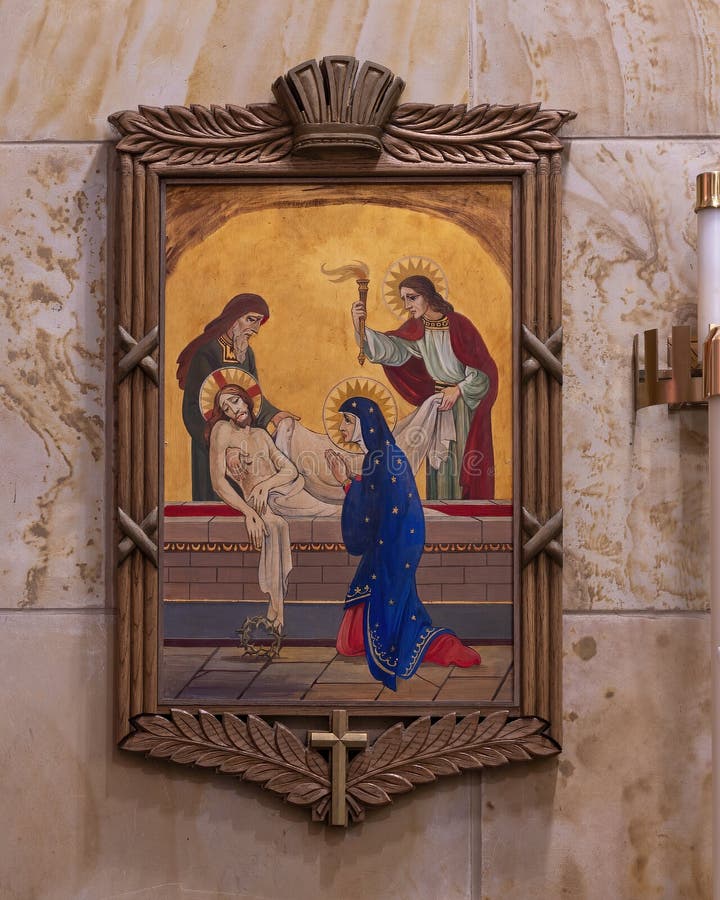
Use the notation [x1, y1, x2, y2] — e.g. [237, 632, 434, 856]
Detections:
[326, 397, 480, 690]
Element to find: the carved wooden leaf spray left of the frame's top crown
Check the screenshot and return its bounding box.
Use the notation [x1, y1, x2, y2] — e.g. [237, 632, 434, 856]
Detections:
[110, 103, 292, 166]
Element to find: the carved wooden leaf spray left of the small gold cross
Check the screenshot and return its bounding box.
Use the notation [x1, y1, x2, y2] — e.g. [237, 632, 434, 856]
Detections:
[121, 709, 330, 817]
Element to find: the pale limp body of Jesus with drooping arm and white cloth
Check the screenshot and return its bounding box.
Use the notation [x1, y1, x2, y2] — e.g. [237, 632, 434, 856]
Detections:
[205, 384, 339, 627]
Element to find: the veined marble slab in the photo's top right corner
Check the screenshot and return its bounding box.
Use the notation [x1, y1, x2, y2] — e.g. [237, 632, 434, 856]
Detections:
[471, 0, 720, 137]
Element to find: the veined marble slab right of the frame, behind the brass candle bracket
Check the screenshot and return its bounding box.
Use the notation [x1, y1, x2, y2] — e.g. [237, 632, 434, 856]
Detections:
[563, 140, 717, 609]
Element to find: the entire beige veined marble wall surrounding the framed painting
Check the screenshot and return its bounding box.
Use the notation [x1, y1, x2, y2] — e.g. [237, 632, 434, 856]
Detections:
[0, 0, 708, 900]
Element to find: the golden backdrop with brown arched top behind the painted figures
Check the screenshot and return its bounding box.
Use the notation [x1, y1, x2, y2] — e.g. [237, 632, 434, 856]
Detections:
[164, 183, 512, 501]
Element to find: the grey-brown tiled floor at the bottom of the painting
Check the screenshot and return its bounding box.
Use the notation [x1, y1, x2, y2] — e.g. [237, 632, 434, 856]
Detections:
[163, 645, 513, 702]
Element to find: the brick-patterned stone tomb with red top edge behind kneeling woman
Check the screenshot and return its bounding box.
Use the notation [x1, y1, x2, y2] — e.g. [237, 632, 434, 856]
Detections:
[162, 501, 513, 645]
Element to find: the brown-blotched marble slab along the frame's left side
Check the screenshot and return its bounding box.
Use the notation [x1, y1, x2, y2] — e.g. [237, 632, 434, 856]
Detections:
[0, 145, 107, 607]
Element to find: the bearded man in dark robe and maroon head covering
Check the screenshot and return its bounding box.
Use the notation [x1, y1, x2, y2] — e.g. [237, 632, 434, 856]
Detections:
[177, 294, 292, 500]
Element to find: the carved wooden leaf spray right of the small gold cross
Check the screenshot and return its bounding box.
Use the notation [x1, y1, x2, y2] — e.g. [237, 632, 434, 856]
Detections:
[346, 710, 560, 820]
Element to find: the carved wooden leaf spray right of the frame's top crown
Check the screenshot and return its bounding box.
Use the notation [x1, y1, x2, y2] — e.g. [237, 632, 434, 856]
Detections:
[382, 103, 575, 165]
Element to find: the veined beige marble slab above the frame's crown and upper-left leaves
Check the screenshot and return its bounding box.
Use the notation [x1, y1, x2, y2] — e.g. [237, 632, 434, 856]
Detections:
[0, 0, 469, 140]
